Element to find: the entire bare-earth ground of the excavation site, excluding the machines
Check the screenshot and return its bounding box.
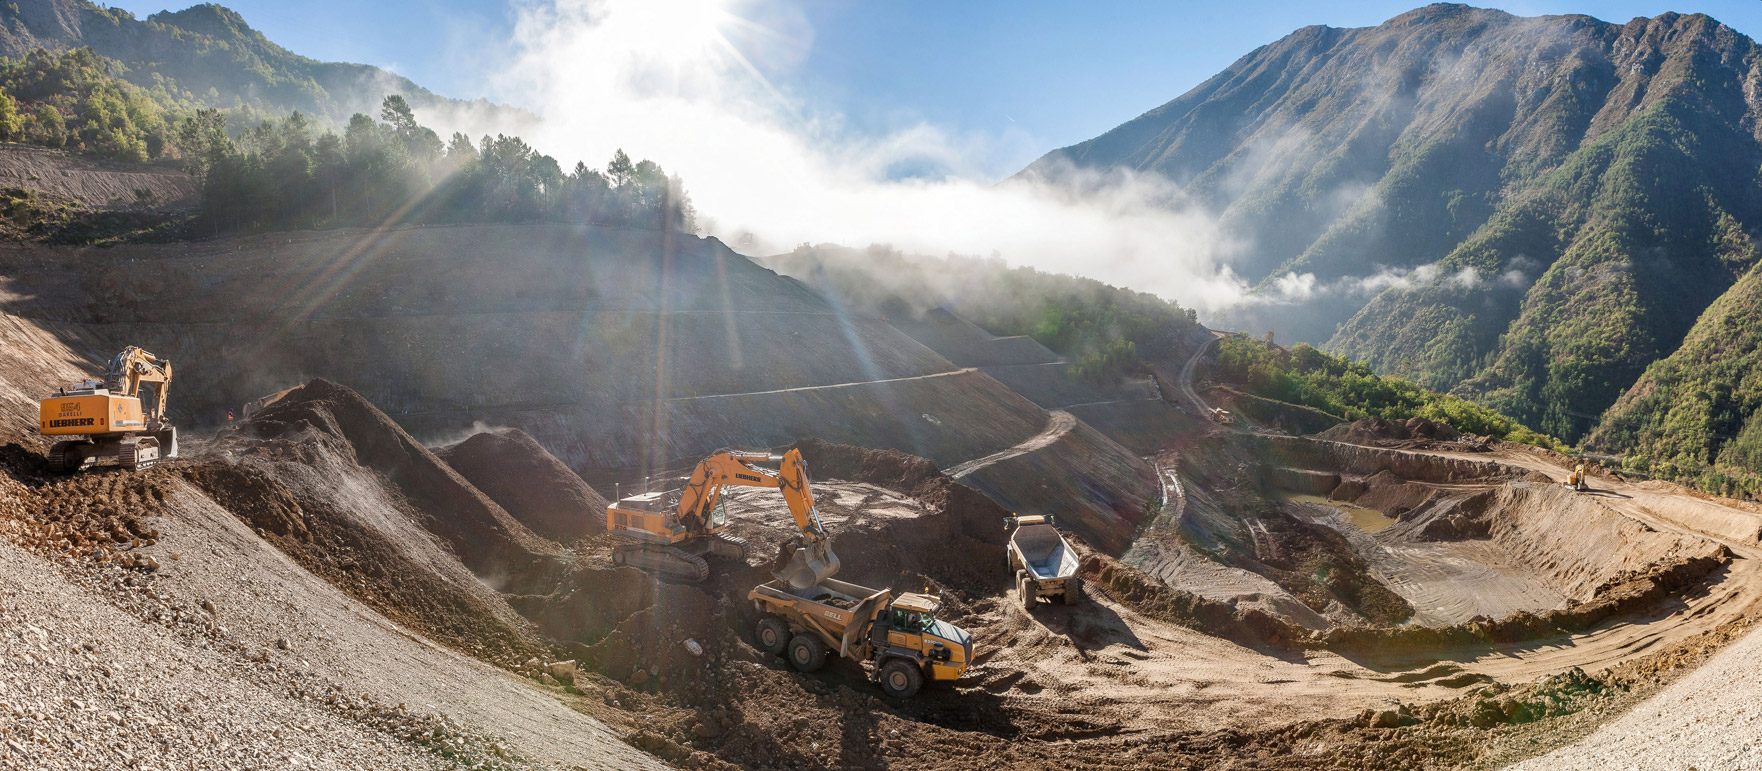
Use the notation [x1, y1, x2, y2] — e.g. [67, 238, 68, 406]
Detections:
[0, 225, 1762, 769]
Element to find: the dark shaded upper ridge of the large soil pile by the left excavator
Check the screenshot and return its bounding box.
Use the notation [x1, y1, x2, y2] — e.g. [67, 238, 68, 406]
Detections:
[240, 378, 562, 584]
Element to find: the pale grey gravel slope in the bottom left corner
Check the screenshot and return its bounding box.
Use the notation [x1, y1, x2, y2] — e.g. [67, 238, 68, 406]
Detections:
[0, 482, 664, 771]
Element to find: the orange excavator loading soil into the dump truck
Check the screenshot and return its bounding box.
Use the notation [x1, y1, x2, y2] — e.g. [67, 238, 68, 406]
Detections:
[606, 449, 839, 586]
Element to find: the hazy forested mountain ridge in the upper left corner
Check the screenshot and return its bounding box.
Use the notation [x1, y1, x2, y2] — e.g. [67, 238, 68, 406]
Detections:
[0, 0, 536, 134]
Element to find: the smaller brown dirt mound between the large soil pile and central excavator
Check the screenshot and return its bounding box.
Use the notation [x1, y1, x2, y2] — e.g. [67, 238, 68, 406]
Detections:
[435, 428, 606, 544]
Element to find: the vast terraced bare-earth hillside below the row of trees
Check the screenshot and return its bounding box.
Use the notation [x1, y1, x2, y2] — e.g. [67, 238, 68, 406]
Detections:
[0, 225, 1155, 535]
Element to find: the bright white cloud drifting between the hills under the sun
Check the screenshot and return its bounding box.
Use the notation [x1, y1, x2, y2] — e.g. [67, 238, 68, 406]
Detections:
[482, 0, 1254, 312]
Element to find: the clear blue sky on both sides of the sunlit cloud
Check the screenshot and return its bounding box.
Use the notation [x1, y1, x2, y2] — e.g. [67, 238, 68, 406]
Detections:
[113, 0, 1762, 174]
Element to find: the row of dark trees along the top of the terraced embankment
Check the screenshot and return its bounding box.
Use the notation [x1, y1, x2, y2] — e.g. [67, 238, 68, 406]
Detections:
[178, 95, 696, 232]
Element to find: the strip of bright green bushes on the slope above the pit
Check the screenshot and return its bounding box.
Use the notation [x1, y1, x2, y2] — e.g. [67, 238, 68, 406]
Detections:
[1218, 336, 1566, 452]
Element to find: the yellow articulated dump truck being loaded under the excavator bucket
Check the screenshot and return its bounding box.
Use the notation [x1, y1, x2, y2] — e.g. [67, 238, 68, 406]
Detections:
[747, 579, 973, 699]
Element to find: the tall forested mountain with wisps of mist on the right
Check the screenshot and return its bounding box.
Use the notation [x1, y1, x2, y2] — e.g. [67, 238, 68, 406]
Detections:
[1024, 5, 1762, 448]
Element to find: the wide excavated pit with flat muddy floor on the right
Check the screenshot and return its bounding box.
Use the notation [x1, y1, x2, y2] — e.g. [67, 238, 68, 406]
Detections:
[1126, 421, 1732, 662]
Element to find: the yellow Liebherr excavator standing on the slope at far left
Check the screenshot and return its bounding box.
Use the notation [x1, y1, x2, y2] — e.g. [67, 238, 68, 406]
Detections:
[37, 345, 178, 472]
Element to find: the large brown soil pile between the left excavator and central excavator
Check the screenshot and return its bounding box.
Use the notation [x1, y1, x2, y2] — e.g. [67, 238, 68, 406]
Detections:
[169, 380, 567, 664]
